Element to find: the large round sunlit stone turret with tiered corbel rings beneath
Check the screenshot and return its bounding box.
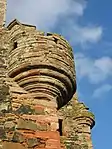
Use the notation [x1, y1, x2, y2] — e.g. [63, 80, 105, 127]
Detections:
[8, 21, 76, 108]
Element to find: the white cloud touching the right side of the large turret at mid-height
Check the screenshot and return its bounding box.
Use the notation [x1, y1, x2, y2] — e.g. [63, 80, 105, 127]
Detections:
[75, 53, 112, 84]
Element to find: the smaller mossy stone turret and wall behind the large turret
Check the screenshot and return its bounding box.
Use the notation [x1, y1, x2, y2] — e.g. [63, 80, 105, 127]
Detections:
[59, 94, 95, 149]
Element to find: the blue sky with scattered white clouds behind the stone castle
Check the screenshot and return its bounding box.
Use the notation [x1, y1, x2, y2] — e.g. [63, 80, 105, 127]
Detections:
[6, 0, 112, 149]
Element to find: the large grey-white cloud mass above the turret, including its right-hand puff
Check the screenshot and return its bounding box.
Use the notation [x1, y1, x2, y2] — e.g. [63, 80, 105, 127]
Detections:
[7, 0, 103, 47]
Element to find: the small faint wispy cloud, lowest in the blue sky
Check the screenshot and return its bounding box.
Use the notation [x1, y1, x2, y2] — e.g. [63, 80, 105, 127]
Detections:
[93, 84, 112, 98]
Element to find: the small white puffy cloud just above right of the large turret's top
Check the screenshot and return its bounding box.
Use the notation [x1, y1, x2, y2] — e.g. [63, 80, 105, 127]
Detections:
[63, 21, 103, 47]
